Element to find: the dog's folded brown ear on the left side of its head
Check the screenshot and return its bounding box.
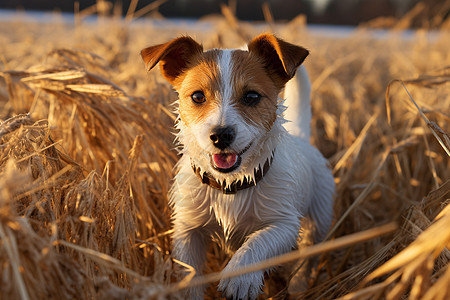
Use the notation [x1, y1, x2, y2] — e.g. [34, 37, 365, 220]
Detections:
[141, 36, 203, 84]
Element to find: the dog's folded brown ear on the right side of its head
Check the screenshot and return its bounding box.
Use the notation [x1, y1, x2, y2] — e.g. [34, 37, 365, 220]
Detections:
[248, 33, 309, 85]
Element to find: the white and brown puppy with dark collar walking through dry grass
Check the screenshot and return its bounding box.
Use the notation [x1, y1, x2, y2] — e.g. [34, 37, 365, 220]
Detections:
[141, 34, 334, 299]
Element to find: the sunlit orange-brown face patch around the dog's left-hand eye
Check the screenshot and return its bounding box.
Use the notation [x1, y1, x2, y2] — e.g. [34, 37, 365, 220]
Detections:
[174, 50, 221, 126]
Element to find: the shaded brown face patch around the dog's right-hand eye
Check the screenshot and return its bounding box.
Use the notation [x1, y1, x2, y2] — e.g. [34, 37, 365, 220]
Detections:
[231, 50, 280, 131]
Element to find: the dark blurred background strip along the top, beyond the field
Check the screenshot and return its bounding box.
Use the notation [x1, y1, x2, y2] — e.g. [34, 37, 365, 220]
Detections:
[0, 0, 450, 28]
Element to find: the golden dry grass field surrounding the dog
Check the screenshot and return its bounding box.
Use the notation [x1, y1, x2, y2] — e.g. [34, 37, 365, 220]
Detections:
[0, 8, 450, 299]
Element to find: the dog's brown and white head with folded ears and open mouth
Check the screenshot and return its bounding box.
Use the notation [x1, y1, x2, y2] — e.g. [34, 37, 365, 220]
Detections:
[141, 34, 308, 180]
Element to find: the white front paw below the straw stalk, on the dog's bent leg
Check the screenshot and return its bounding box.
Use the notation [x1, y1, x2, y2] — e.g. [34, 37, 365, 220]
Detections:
[218, 268, 264, 300]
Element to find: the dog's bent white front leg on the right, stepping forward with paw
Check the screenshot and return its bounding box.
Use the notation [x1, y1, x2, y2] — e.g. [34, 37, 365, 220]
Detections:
[219, 218, 300, 299]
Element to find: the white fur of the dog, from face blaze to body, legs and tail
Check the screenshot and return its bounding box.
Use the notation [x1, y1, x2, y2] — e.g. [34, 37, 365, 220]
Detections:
[170, 50, 334, 299]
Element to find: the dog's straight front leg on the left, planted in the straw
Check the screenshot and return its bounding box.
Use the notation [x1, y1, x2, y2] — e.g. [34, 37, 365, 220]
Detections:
[173, 223, 207, 299]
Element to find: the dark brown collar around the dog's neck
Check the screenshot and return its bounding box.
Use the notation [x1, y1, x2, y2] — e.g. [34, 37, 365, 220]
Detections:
[191, 153, 274, 194]
